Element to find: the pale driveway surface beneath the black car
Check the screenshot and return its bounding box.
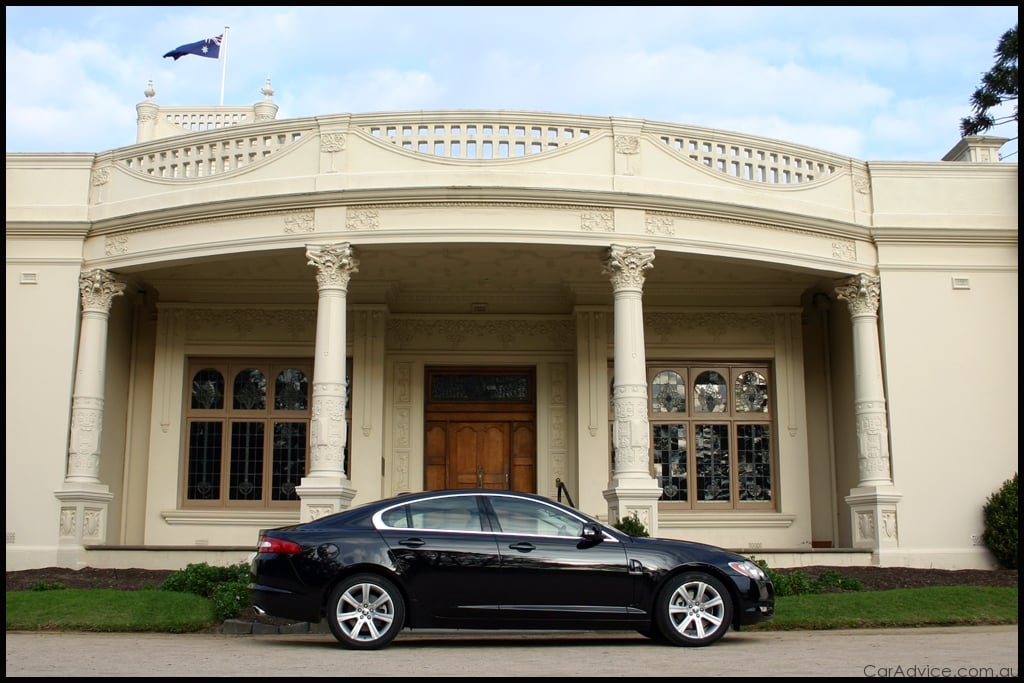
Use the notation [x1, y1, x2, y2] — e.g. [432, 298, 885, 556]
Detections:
[6, 625, 1019, 678]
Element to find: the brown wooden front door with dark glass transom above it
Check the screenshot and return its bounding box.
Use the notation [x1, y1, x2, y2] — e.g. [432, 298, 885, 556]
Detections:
[424, 368, 537, 493]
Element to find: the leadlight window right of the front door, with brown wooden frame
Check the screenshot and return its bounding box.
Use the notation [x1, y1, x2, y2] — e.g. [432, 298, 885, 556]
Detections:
[611, 361, 777, 510]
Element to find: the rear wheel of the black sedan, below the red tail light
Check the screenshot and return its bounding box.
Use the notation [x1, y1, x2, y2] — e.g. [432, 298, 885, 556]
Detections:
[327, 574, 406, 650]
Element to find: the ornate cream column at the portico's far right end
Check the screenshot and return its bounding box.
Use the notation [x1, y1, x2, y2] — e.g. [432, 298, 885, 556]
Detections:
[836, 273, 902, 559]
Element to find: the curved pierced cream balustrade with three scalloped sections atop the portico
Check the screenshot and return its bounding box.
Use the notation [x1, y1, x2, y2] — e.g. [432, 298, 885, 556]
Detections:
[116, 112, 850, 186]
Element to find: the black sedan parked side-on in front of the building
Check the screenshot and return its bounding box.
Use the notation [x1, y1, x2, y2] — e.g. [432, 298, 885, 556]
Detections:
[249, 489, 775, 650]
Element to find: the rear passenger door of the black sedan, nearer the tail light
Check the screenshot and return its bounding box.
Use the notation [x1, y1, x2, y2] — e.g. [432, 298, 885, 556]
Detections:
[378, 495, 501, 621]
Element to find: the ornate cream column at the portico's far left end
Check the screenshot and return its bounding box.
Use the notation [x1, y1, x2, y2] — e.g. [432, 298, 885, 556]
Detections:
[54, 269, 125, 566]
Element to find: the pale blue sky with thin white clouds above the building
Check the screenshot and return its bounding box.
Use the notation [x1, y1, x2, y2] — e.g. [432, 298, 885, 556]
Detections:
[6, 5, 1018, 162]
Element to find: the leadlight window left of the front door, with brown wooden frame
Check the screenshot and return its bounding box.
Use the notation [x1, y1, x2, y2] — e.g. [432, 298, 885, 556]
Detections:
[183, 358, 312, 508]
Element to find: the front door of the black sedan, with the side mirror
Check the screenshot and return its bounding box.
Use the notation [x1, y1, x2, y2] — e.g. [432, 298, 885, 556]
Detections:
[487, 495, 635, 626]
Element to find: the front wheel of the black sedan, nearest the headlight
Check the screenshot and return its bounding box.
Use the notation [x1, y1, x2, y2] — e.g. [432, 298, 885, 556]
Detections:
[655, 571, 732, 647]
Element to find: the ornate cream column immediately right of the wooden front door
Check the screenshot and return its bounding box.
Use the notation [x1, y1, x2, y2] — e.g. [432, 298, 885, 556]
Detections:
[604, 245, 662, 536]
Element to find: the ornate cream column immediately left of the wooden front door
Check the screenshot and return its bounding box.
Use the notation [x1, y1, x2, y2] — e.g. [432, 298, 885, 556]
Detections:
[296, 243, 359, 521]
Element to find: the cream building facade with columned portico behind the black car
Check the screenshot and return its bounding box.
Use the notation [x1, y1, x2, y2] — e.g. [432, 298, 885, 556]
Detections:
[6, 83, 1018, 570]
